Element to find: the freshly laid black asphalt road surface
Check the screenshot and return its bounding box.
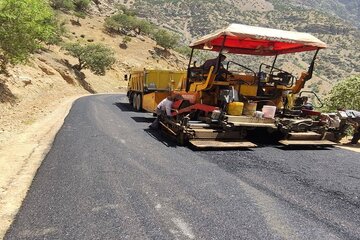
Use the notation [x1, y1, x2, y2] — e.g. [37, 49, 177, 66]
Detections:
[5, 95, 360, 240]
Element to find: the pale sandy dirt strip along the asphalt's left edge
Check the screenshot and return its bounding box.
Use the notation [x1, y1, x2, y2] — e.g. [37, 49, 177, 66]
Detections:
[0, 95, 87, 239]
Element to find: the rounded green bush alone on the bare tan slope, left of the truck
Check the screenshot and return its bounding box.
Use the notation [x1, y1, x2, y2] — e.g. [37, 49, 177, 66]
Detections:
[64, 43, 115, 75]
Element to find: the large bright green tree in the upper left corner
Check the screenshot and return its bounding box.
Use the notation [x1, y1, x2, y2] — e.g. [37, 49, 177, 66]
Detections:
[0, 0, 58, 71]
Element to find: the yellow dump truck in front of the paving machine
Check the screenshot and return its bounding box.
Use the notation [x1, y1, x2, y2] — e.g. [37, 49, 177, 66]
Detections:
[127, 69, 186, 112]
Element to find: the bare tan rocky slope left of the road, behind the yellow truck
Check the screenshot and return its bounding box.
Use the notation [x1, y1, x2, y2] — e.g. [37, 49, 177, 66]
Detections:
[0, 14, 186, 145]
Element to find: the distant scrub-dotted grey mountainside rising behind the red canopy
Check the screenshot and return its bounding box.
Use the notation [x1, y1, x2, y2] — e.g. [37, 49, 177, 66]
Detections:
[93, 0, 360, 95]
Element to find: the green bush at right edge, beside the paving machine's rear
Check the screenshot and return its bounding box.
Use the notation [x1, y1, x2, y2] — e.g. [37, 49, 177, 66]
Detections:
[325, 76, 360, 111]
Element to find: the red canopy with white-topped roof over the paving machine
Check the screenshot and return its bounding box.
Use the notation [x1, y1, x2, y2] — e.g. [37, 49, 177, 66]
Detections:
[190, 24, 327, 56]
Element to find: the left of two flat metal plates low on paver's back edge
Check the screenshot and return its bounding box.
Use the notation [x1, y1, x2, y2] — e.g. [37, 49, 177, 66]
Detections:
[189, 139, 257, 148]
